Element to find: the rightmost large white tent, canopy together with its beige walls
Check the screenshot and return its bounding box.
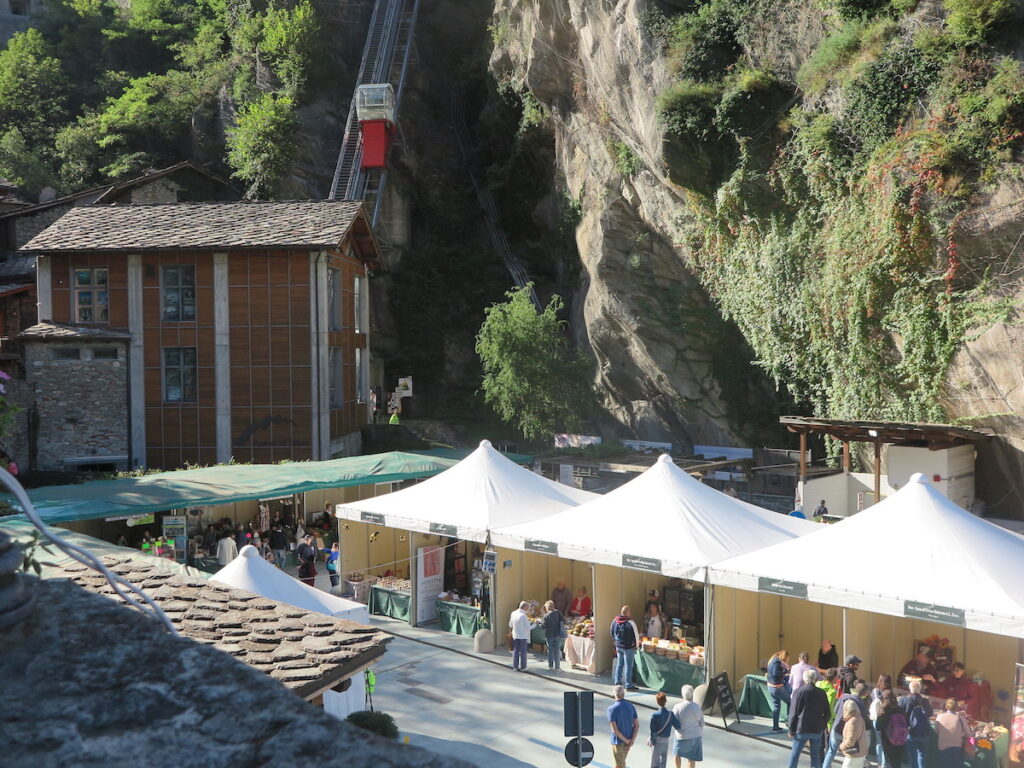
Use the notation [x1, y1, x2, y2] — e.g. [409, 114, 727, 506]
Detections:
[710, 475, 1024, 723]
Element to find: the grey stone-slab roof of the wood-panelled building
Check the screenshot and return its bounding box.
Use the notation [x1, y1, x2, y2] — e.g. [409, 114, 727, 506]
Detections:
[22, 201, 361, 253]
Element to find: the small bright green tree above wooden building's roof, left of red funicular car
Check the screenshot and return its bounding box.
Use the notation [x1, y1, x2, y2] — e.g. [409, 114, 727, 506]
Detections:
[227, 93, 297, 198]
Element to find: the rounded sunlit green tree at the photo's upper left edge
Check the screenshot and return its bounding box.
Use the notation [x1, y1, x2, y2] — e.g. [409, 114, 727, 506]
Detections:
[0, 30, 68, 146]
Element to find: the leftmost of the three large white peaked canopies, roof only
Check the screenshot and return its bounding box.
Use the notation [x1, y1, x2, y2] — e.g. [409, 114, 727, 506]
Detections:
[335, 440, 598, 542]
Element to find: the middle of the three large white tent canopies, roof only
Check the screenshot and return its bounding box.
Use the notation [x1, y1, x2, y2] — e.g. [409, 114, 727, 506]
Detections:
[487, 456, 818, 581]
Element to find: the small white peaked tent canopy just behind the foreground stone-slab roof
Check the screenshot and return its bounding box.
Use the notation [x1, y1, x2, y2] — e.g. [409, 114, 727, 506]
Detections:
[210, 544, 370, 624]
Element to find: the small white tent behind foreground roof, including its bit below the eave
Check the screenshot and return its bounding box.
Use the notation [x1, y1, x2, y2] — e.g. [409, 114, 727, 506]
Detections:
[210, 544, 370, 720]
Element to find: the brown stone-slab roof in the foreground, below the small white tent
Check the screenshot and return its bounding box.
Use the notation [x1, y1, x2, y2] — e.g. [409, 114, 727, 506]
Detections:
[63, 556, 390, 698]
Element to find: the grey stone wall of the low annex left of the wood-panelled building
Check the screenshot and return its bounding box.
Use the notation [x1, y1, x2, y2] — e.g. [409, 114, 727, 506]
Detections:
[25, 341, 129, 471]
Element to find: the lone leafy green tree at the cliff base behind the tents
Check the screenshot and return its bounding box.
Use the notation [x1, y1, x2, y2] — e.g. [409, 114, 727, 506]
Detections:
[476, 285, 592, 438]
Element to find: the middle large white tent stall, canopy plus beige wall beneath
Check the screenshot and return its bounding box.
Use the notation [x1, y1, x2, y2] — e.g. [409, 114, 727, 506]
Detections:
[492, 456, 818, 672]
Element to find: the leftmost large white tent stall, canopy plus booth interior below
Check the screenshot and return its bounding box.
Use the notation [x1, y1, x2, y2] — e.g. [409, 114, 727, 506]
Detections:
[335, 440, 596, 642]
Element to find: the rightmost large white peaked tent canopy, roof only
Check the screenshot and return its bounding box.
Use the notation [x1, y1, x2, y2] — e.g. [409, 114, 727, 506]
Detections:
[710, 474, 1024, 638]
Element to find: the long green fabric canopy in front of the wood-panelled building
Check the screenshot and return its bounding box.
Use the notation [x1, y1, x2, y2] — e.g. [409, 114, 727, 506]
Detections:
[5, 451, 457, 524]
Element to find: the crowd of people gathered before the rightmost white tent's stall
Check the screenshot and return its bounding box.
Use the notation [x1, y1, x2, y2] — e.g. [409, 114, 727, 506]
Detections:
[766, 641, 971, 768]
